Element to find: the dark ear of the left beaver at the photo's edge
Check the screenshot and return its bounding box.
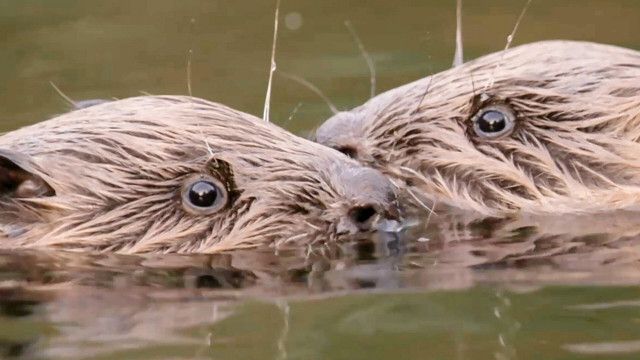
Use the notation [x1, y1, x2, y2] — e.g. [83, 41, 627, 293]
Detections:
[0, 149, 55, 198]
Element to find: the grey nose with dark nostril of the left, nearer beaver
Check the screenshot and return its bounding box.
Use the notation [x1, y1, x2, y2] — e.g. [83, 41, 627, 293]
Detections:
[337, 167, 400, 234]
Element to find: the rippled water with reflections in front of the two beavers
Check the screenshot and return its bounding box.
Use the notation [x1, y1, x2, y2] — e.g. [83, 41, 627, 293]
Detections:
[0, 214, 640, 359]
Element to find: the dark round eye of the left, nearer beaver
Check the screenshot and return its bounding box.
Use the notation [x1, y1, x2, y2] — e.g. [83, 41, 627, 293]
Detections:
[182, 177, 227, 215]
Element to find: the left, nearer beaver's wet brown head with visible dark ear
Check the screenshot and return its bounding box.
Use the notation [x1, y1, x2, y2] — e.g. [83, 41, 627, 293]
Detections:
[0, 96, 398, 253]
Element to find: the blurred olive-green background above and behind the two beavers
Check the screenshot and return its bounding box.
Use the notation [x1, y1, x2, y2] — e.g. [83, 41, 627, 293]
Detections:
[0, 0, 640, 132]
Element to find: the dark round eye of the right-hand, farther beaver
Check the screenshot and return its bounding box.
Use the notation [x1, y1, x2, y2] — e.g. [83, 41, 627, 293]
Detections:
[473, 105, 516, 139]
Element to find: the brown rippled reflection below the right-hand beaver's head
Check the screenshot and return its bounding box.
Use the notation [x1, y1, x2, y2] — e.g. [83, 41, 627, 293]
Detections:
[410, 212, 640, 271]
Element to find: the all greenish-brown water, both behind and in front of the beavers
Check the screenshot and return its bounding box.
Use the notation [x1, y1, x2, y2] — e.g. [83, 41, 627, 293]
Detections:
[0, 0, 640, 360]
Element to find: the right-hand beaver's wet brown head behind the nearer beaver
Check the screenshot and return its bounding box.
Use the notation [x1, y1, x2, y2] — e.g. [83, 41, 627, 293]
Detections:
[316, 41, 640, 216]
